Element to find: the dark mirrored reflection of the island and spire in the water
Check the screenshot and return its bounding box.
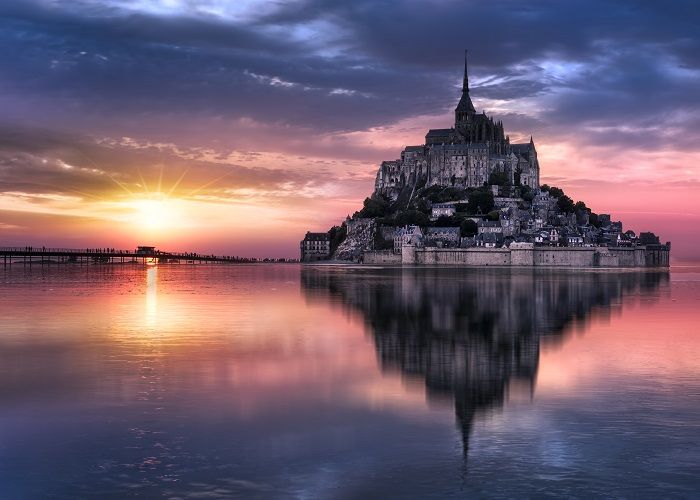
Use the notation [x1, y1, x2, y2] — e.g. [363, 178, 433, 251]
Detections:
[301, 268, 668, 458]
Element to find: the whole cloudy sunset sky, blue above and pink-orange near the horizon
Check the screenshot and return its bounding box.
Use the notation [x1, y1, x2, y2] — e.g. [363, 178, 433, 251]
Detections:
[0, 0, 700, 261]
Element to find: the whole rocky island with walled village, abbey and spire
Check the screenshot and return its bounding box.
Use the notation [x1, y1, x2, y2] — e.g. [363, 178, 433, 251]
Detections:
[300, 52, 671, 267]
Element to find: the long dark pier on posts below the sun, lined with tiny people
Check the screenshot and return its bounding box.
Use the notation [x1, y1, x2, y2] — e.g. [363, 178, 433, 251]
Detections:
[0, 246, 252, 266]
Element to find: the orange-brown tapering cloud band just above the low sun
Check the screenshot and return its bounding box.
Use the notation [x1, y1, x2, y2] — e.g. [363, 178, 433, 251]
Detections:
[0, 127, 336, 204]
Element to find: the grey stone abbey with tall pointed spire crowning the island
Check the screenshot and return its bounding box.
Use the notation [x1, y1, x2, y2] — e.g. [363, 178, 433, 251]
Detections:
[375, 51, 540, 200]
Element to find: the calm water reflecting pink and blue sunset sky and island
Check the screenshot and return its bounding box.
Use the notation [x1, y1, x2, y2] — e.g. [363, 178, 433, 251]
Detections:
[0, 265, 700, 499]
